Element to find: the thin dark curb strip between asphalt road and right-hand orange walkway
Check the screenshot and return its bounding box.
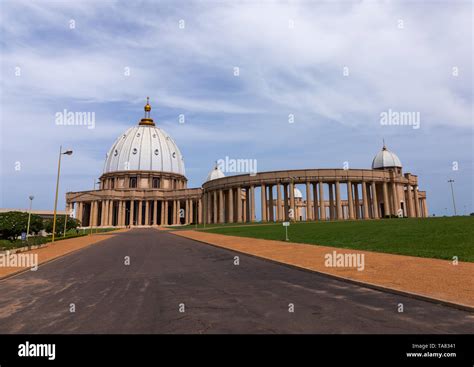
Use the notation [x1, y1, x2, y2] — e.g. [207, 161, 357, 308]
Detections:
[169, 231, 474, 313]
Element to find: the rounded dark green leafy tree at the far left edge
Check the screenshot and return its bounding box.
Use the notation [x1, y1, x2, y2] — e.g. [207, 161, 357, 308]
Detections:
[0, 211, 43, 241]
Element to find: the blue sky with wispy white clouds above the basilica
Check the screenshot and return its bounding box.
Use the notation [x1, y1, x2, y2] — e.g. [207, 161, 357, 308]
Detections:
[0, 0, 474, 215]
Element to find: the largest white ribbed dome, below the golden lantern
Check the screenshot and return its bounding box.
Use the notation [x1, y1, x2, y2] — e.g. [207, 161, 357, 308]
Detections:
[104, 125, 185, 176]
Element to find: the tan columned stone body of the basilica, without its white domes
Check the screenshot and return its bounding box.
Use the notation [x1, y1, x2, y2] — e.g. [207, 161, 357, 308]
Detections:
[66, 169, 428, 227]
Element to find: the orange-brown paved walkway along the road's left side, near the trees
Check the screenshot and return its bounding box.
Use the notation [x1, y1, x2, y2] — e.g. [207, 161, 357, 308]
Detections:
[0, 229, 127, 279]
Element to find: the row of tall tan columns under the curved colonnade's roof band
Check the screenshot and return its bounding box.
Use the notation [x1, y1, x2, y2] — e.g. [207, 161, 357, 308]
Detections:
[204, 180, 428, 223]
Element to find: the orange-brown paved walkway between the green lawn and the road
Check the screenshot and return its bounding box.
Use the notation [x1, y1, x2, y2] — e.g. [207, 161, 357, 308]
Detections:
[173, 230, 474, 308]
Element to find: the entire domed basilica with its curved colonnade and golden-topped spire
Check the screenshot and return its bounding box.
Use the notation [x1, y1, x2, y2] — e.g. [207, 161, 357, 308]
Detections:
[66, 100, 428, 227]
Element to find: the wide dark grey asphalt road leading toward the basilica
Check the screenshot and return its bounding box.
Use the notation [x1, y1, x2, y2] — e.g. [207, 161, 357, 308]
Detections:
[0, 229, 474, 333]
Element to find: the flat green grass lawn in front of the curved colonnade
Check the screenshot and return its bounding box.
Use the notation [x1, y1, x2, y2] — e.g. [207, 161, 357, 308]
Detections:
[207, 216, 474, 262]
